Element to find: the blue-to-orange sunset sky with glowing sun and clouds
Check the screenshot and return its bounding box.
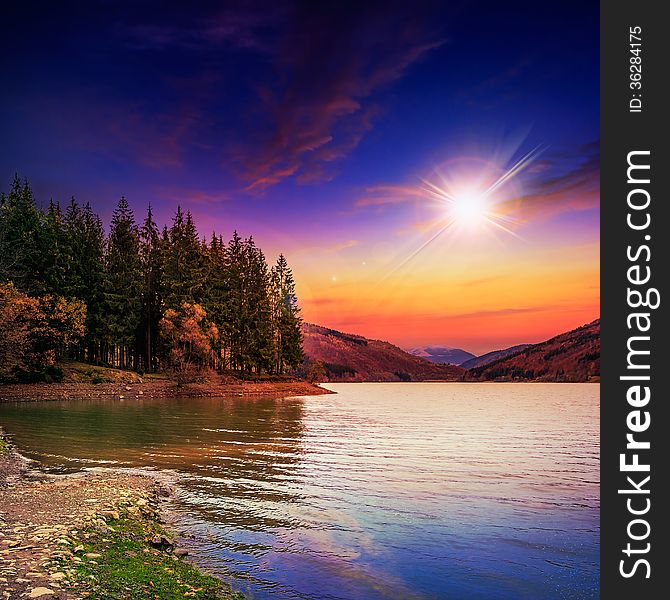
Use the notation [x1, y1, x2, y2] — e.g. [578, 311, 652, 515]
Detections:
[0, 0, 600, 354]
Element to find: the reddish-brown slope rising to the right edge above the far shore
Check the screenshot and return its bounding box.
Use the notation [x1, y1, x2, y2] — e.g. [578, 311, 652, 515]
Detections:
[466, 319, 600, 382]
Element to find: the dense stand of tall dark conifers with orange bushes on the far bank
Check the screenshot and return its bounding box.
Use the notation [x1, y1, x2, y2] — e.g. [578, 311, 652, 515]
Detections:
[0, 176, 303, 381]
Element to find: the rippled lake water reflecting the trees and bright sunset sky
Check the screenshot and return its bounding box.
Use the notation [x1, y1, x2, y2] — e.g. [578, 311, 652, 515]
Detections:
[0, 384, 599, 600]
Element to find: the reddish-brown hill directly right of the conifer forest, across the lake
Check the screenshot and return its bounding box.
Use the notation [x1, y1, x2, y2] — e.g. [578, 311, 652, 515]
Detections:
[302, 323, 465, 381]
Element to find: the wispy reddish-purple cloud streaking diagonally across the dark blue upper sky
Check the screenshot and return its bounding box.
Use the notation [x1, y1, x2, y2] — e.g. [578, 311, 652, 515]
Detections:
[236, 3, 443, 190]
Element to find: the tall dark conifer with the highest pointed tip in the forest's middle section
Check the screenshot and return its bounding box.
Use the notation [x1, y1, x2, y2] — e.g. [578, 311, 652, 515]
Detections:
[105, 196, 142, 368]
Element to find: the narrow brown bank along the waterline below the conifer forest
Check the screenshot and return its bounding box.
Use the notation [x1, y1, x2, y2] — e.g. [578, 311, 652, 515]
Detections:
[0, 379, 334, 402]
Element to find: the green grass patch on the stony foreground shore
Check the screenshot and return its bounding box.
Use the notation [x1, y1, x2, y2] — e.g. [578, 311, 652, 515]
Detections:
[64, 513, 244, 600]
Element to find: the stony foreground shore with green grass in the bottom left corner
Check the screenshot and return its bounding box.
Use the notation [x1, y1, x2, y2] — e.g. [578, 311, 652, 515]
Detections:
[0, 428, 244, 600]
